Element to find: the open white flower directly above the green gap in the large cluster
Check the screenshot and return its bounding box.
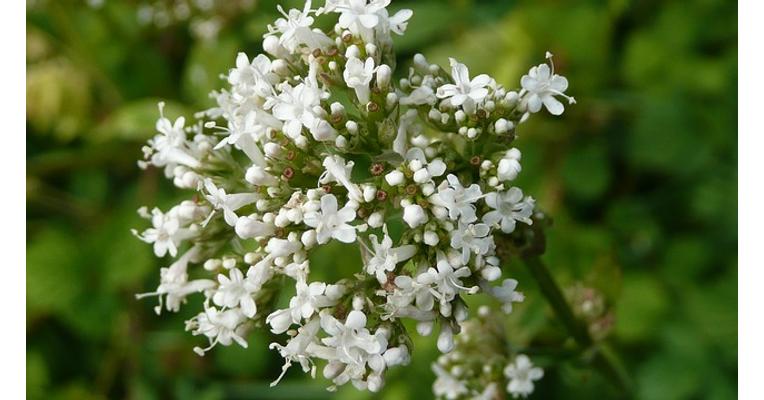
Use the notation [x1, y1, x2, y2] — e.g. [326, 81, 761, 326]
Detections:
[303, 194, 356, 244]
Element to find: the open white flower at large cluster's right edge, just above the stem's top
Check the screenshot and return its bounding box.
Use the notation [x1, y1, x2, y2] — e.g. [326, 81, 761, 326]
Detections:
[483, 187, 535, 233]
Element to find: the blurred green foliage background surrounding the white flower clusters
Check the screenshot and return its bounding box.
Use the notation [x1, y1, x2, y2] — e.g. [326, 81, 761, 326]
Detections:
[26, 0, 737, 399]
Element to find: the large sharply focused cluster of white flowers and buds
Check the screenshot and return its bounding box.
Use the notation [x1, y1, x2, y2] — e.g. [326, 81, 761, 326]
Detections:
[136, 0, 573, 391]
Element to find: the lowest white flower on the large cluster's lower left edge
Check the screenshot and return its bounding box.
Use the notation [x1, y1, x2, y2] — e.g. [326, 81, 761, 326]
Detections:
[186, 307, 247, 356]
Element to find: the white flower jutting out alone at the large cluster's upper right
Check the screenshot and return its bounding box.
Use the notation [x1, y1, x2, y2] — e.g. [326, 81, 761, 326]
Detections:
[520, 54, 576, 115]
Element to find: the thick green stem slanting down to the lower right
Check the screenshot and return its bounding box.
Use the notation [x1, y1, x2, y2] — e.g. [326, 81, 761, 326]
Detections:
[524, 256, 631, 397]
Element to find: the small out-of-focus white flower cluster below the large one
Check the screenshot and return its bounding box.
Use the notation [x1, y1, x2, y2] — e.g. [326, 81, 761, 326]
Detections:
[432, 306, 544, 400]
